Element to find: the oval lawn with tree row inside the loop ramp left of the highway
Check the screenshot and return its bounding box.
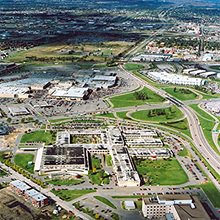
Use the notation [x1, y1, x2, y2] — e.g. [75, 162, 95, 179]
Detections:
[131, 106, 183, 122]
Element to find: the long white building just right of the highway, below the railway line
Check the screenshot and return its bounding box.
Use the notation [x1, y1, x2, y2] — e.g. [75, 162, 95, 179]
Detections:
[148, 72, 205, 86]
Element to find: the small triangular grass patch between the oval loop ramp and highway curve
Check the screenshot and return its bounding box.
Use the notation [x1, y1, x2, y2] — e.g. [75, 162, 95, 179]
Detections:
[161, 119, 191, 137]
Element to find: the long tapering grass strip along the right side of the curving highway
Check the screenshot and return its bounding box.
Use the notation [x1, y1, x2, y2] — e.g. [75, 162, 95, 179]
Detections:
[190, 104, 220, 154]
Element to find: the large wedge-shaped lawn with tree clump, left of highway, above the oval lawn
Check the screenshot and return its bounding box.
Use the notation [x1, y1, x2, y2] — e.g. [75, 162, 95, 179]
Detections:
[110, 87, 164, 108]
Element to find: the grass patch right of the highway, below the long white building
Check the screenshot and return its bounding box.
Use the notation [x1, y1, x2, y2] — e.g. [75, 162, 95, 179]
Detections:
[163, 87, 198, 101]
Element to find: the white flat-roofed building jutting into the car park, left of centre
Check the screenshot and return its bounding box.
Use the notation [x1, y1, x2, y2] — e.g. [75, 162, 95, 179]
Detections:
[51, 87, 89, 101]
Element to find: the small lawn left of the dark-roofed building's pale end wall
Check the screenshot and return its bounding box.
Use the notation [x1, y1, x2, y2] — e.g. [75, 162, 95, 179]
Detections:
[14, 154, 34, 173]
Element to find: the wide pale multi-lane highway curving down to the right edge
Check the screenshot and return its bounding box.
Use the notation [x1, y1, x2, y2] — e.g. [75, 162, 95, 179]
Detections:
[120, 66, 220, 190]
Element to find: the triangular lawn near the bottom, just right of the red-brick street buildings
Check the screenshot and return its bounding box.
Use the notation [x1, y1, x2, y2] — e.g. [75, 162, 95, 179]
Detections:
[51, 189, 96, 201]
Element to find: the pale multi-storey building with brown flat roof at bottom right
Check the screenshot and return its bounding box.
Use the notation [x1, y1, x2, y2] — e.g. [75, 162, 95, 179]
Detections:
[142, 195, 210, 220]
